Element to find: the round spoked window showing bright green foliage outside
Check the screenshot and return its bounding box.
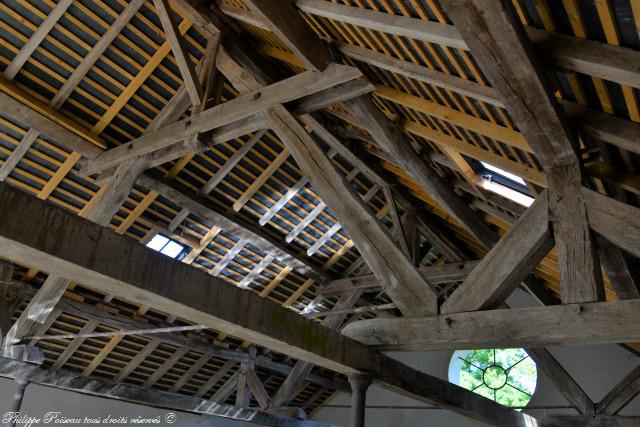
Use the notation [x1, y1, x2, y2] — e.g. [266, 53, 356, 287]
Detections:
[449, 348, 538, 408]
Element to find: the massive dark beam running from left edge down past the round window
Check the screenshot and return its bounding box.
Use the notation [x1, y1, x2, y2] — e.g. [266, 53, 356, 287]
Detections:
[0, 184, 548, 427]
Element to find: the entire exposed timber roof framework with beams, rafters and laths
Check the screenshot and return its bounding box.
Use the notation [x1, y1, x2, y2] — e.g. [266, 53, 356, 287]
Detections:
[0, 0, 640, 426]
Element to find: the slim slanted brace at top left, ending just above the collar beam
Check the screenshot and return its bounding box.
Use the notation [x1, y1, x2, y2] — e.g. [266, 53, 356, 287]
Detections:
[153, 0, 204, 106]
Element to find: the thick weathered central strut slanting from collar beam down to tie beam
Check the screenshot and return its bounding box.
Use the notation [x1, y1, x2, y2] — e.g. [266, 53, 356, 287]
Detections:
[266, 107, 437, 315]
